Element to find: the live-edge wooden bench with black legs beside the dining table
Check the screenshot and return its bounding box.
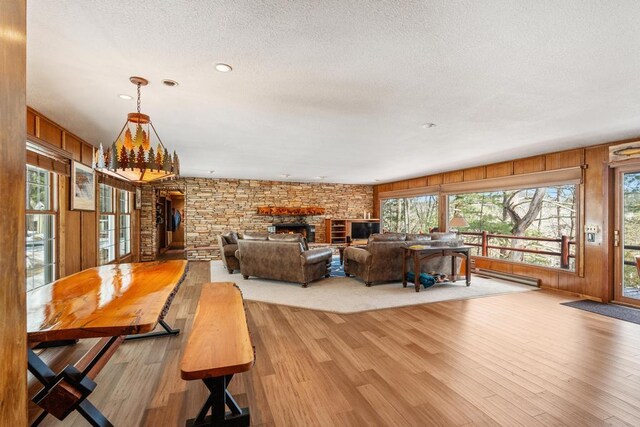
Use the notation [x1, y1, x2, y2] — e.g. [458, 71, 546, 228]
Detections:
[180, 282, 254, 427]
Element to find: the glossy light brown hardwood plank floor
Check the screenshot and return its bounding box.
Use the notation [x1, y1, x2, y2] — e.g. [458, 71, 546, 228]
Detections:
[30, 262, 640, 426]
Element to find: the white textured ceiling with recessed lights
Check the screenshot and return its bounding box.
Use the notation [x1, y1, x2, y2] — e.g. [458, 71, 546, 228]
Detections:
[27, 0, 640, 183]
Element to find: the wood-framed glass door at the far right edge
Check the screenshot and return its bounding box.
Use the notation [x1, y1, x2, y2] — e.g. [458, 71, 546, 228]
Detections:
[614, 165, 640, 305]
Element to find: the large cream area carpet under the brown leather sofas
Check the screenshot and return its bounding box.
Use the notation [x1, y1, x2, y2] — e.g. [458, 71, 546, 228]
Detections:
[211, 261, 538, 313]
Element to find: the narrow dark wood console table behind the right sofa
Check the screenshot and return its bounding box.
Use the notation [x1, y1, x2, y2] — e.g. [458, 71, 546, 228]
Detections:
[402, 245, 471, 292]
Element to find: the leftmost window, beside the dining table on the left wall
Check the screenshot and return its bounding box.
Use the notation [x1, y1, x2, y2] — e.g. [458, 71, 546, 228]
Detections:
[25, 165, 56, 291]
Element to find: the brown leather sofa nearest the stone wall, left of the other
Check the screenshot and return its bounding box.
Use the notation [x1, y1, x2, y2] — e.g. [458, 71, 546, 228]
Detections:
[236, 233, 332, 288]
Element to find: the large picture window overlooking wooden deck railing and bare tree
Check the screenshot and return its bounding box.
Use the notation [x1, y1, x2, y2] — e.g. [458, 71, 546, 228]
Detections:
[449, 184, 578, 271]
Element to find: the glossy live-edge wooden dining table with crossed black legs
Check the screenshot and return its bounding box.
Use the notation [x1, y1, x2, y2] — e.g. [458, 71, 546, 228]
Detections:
[27, 260, 187, 426]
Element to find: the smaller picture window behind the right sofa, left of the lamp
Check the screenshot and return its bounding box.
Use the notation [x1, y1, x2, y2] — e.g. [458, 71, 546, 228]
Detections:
[381, 195, 438, 233]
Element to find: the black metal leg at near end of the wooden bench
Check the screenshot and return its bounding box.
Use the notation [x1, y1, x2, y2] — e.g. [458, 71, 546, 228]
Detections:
[186, 375, 251, 427]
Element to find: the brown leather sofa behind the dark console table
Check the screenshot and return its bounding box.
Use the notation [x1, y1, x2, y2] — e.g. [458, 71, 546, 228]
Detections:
[344, 233, 461, 286]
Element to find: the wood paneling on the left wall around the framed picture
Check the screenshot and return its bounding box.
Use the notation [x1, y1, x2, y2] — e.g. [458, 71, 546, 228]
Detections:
[26, 108, 140, 277]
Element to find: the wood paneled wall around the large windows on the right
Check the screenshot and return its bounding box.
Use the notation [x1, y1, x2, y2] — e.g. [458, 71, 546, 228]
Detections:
[374, 145, 620, 301]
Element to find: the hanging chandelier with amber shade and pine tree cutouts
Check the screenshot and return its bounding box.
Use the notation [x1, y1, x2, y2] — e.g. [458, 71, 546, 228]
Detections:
[95, 77, 180, 182]
